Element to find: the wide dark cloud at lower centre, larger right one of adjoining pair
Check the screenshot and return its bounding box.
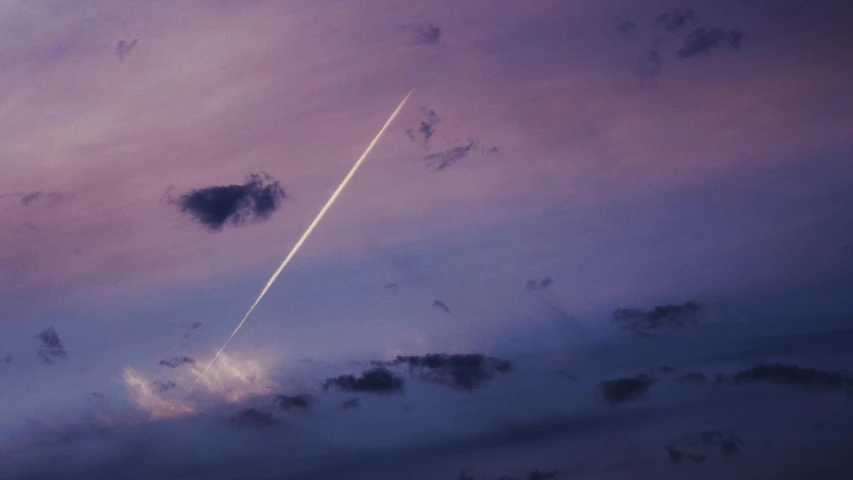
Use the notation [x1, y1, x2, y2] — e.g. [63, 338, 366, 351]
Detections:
[392, 353, 512, 391]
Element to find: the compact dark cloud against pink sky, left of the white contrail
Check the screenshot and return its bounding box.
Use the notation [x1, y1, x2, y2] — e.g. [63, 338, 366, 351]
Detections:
[173, 174, 286, 231]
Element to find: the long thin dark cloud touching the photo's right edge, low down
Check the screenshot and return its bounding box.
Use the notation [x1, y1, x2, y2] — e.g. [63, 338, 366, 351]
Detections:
[729, 363, 853, 390]
